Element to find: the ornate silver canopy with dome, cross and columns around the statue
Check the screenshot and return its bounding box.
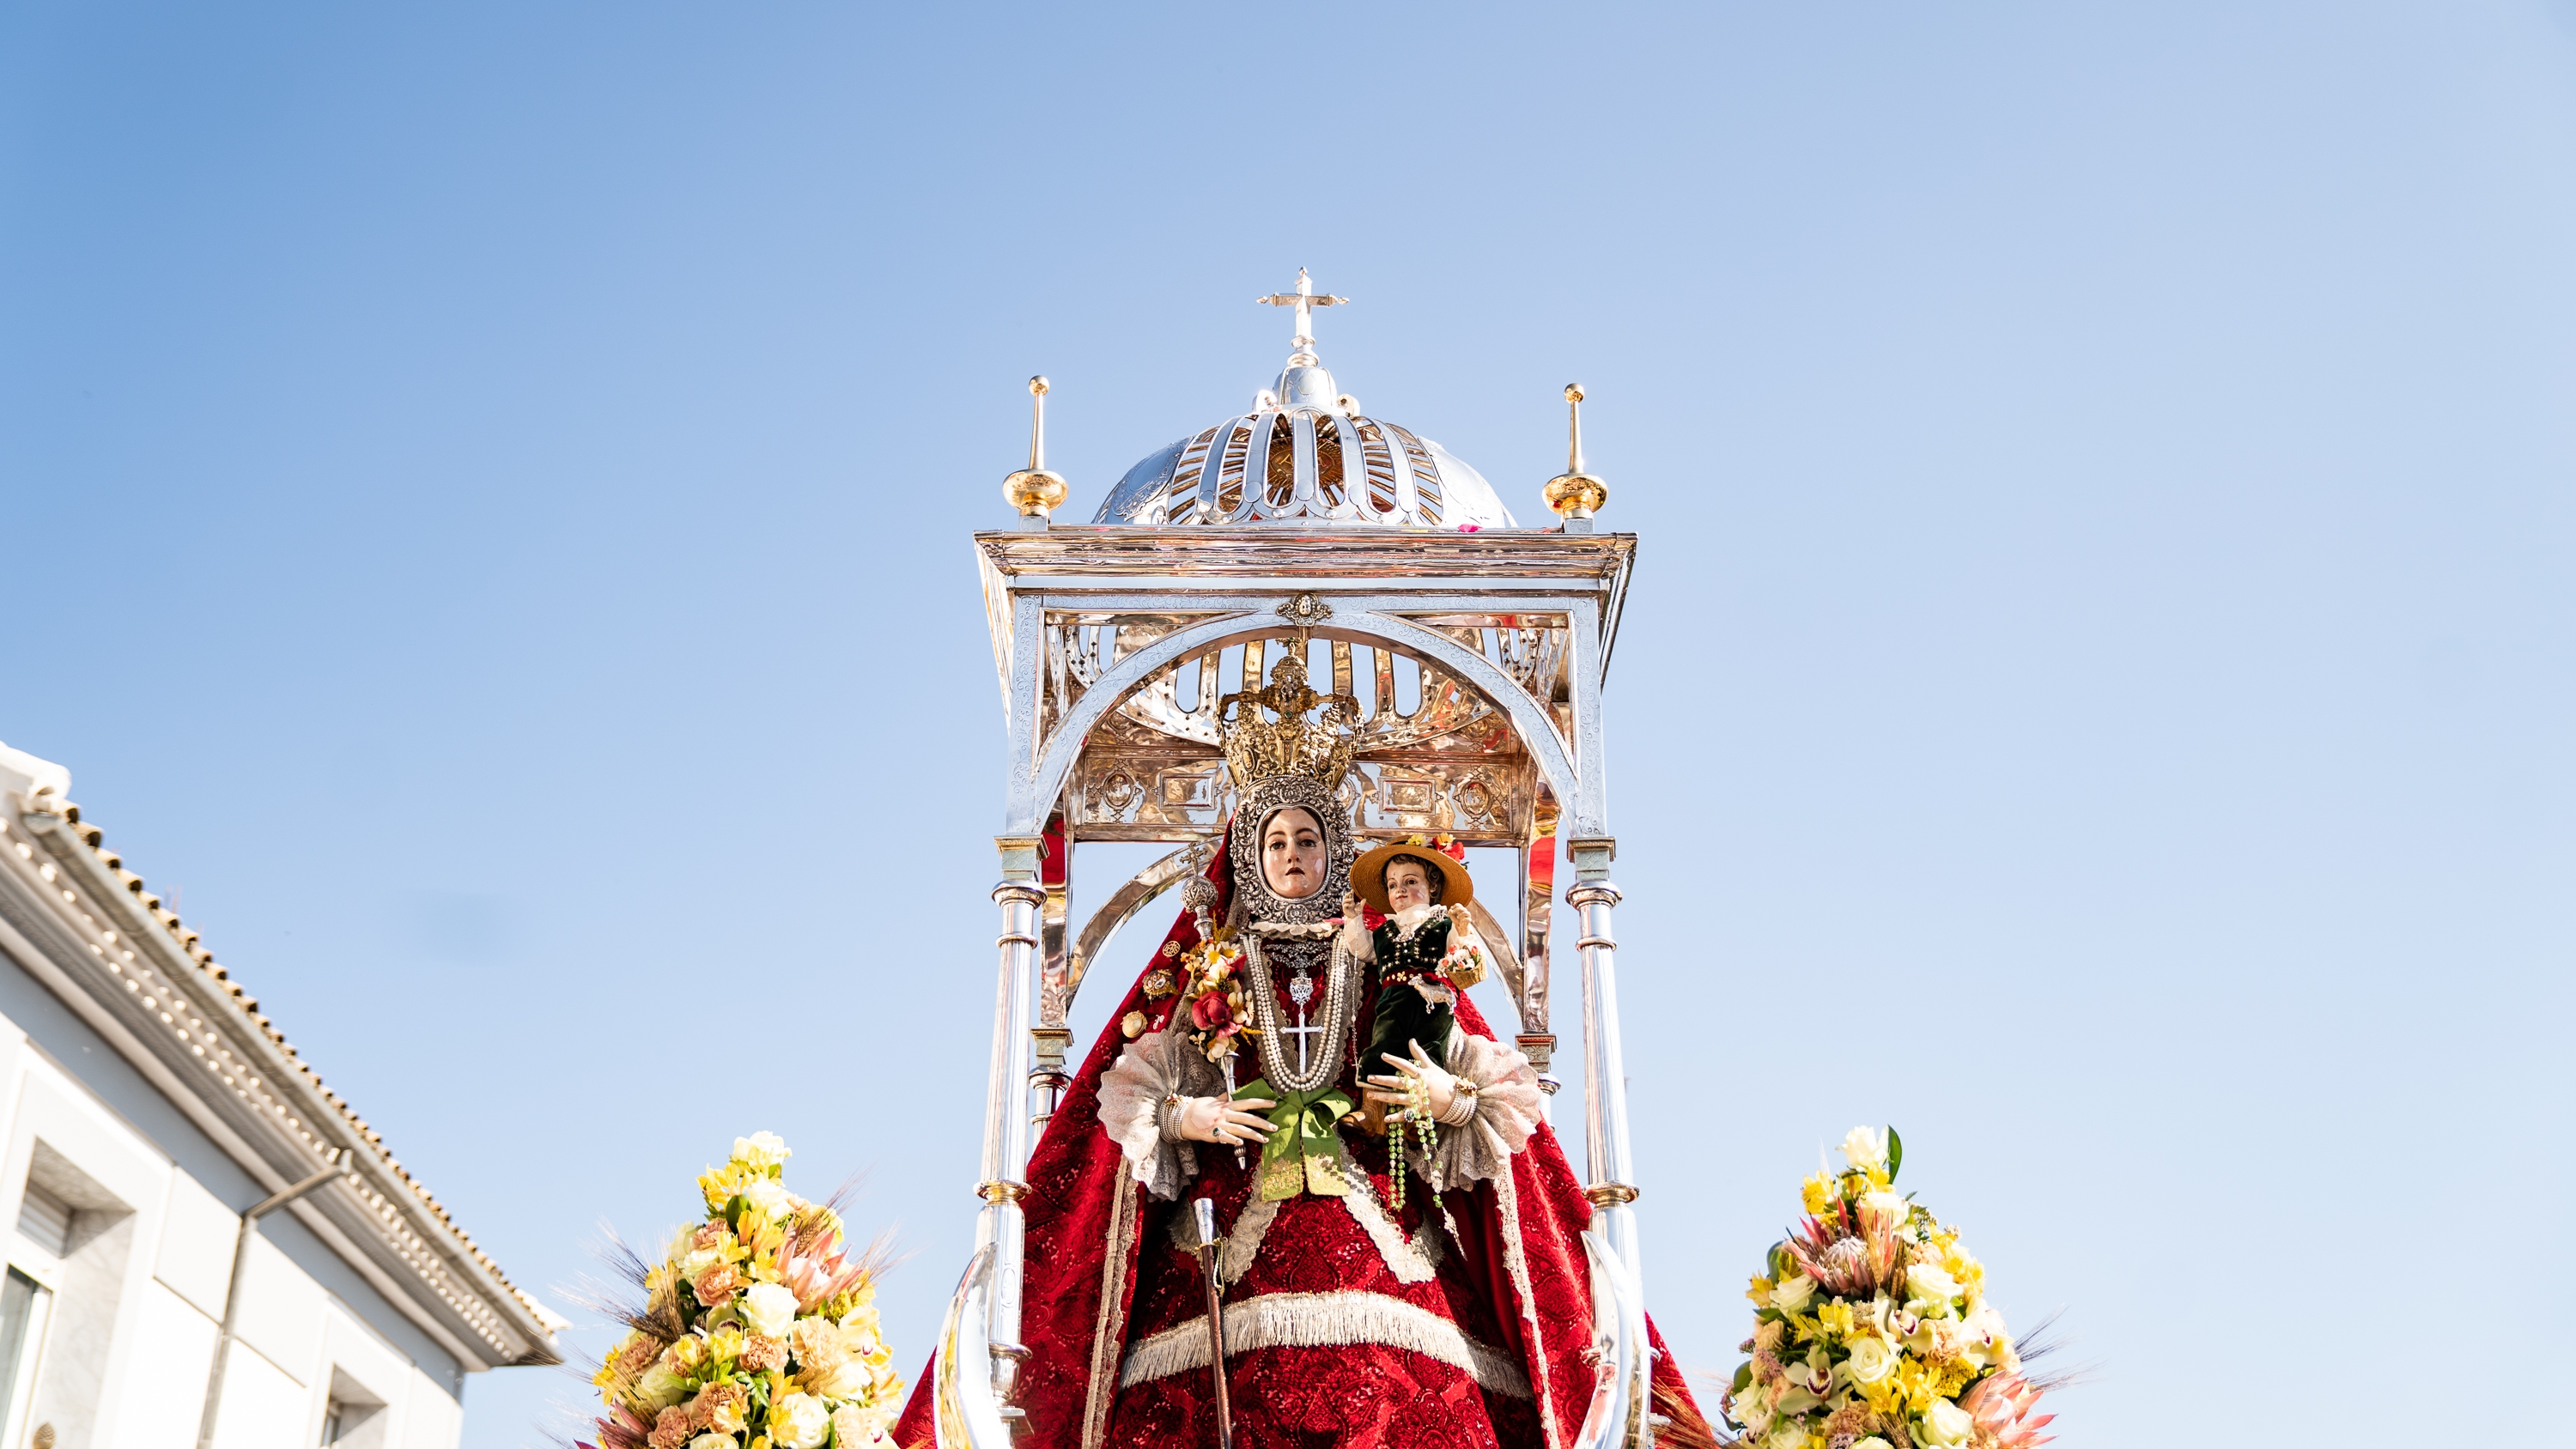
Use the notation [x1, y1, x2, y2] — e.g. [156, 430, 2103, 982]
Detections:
[938, 273, 1654, 1449]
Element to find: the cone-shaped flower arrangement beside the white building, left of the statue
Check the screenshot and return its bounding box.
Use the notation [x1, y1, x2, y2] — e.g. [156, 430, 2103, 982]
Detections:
[585, 1132, 904, 1449]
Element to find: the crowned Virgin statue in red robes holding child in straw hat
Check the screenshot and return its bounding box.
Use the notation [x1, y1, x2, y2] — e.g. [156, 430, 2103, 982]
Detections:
[894, 654, 1710, 1449]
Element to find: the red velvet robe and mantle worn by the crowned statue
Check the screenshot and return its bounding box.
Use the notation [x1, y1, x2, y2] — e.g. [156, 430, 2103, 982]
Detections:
[894, 849, 1708, 1449]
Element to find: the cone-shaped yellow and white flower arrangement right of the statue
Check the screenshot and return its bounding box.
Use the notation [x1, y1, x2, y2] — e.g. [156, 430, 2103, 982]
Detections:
[1723, 1127, 2056, 1449]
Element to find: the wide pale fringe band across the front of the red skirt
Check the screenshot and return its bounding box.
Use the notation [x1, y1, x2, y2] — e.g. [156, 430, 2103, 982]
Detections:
[1118, 1292, 1530, 1397]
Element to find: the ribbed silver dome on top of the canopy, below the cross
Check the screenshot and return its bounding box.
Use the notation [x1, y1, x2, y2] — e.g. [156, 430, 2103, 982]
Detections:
[1092, 358, 1517, 530]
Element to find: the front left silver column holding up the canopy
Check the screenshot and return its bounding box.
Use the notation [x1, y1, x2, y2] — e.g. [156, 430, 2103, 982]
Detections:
[976, 836, 1046, 1403]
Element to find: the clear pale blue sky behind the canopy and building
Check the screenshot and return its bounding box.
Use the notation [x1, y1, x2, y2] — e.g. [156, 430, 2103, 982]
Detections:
[0, 0, 2576, 1449]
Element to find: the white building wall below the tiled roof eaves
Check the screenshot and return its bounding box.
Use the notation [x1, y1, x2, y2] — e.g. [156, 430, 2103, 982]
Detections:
[0, 1016, 461, 1449]
